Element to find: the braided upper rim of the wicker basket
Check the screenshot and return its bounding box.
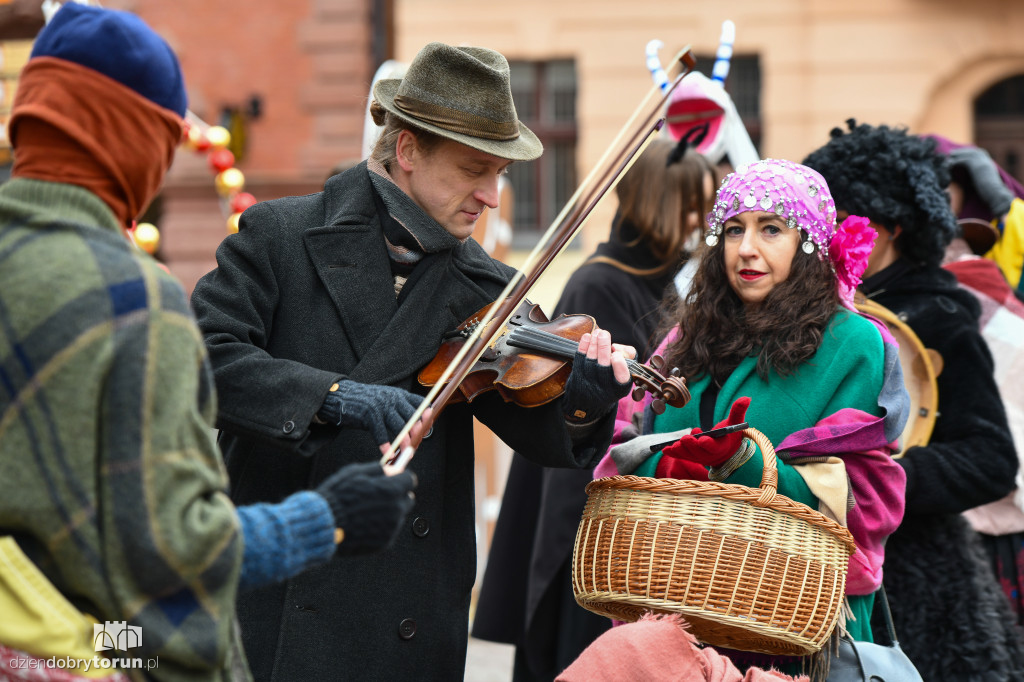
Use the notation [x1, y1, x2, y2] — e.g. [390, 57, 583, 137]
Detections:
[586, 474, 857, 556]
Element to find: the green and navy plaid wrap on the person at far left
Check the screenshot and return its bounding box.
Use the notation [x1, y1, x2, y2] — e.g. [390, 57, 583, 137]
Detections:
[0, 178, 242, 680]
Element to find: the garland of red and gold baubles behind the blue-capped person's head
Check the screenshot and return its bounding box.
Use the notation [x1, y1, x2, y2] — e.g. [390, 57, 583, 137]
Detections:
[130, 114, 256, 255]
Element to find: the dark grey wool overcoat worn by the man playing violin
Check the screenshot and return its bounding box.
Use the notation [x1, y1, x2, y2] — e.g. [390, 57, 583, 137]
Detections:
[193, 163, 612, 682]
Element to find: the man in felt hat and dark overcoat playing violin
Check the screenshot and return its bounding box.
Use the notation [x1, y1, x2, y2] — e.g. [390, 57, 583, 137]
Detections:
[193, 43, 632, 681]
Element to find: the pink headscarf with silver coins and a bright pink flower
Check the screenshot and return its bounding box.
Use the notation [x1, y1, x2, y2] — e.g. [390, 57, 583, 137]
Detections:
[706, 159, 877, 308]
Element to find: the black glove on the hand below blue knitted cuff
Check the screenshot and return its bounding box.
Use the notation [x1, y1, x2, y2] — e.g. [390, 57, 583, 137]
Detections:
[315, 462, 416, 555]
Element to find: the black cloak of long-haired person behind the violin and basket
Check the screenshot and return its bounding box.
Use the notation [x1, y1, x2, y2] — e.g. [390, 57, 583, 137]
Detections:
[473, 219, 676, 681]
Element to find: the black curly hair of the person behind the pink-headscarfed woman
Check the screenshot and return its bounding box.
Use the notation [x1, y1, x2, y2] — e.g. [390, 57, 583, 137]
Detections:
[803, 119, 956, 265]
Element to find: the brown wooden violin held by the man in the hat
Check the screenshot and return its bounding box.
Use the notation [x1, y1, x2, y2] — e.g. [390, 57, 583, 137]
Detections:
[418, 299, 690, 415]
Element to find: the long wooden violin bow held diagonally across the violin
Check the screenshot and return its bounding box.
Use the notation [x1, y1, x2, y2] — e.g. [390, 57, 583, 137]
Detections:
[381, 47, 696, 466]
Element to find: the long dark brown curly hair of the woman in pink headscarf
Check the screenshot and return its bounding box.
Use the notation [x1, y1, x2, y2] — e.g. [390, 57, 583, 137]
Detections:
[665, 233, 840, 385]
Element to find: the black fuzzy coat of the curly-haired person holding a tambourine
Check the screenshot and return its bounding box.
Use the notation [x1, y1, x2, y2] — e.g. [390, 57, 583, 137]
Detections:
[862, 260, 1024, 682]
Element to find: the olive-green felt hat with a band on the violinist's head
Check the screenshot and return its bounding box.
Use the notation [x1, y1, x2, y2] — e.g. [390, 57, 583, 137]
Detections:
[374, 43, 544, 161]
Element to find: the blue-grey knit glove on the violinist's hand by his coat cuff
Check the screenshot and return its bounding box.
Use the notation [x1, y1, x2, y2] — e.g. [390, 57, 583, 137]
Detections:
[316, 379, 423, 444]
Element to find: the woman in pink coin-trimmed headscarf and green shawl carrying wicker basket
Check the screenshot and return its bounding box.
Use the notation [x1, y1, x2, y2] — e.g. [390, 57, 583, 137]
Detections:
[595, 159, 909, 672]
